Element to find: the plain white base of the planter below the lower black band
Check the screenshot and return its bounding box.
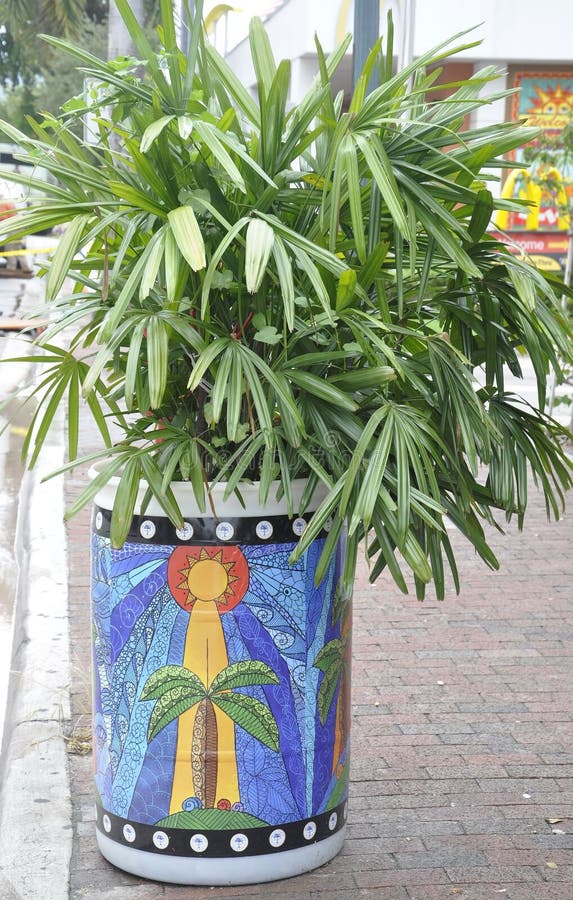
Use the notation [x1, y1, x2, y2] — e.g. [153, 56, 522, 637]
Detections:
[96, 826, 346, 886]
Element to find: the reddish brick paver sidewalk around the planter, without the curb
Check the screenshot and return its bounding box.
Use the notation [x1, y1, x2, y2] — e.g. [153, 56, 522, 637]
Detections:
[66, 440, 573, 900]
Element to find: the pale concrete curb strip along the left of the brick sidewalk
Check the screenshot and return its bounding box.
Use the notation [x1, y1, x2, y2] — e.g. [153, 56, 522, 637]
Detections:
[0, 404, 72, 900]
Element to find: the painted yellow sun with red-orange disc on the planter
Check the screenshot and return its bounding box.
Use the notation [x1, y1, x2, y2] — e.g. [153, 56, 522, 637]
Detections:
[164, 547, 249, 613]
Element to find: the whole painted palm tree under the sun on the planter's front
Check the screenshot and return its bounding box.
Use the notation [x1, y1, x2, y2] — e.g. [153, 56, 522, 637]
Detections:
[141, 660, 279, 811]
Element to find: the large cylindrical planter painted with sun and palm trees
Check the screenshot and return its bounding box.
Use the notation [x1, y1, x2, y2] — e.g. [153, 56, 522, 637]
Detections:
[92, 483, 350, 885]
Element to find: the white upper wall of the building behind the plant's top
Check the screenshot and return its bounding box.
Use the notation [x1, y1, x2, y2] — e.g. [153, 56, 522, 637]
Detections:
[220, 0, 573, 103]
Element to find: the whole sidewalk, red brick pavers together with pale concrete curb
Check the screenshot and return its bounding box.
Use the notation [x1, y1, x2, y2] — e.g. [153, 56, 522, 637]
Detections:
[0, 270, 573, 900]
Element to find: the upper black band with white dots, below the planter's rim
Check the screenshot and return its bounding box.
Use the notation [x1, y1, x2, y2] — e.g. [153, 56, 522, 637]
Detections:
[92, 507, 329, 546]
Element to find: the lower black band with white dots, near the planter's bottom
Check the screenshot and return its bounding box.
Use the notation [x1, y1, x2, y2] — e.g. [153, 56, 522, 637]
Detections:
[96, 802, 347, 858]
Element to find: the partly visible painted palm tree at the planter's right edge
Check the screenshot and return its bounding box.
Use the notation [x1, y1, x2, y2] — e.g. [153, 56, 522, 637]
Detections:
[314, 581, 352, 772]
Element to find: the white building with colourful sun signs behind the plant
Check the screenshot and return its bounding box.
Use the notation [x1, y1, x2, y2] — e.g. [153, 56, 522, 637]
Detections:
[205, 0, 573, 270]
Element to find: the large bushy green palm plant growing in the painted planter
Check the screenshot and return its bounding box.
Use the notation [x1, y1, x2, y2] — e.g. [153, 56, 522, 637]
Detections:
[2, 0, 573, 597]
